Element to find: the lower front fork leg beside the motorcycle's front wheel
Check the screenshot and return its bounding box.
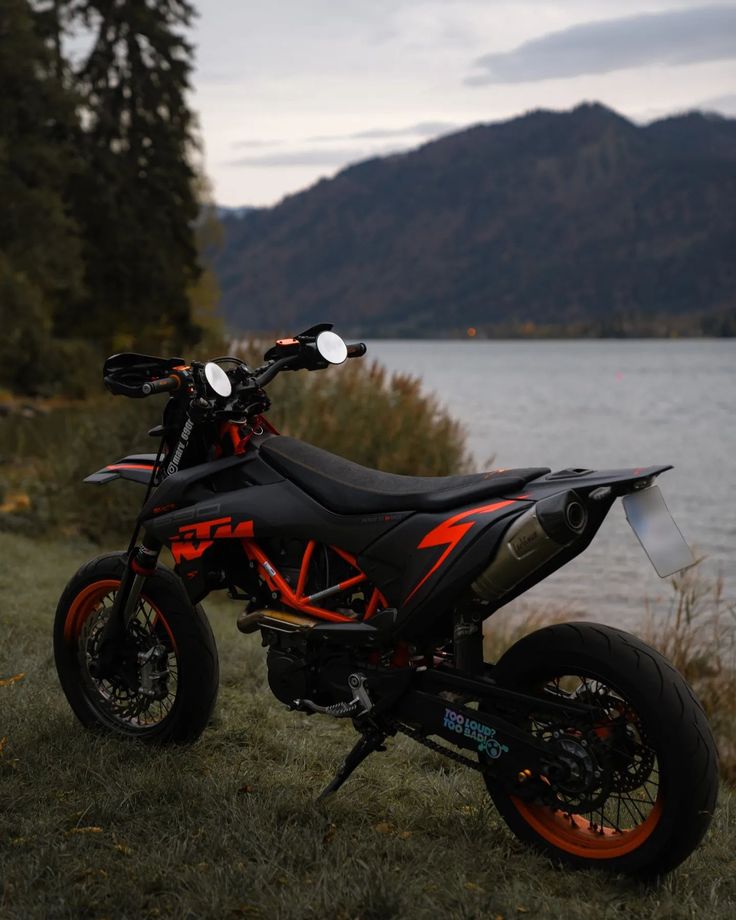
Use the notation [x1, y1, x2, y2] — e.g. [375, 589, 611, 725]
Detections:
[89, 537, 163, 680]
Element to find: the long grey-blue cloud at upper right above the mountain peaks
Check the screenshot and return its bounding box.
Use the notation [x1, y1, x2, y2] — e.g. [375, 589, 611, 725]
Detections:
[465, 6, 736, 86]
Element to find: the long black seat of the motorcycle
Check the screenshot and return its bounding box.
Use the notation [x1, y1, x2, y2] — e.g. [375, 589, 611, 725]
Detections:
[260, 435, 549, 514]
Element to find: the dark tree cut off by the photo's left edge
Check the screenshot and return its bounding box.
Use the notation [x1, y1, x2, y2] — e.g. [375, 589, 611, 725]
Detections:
[0, 0, 82, 390]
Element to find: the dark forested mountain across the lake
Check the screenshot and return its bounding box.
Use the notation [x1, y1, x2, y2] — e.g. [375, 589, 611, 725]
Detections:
[213, 104, 736, 336]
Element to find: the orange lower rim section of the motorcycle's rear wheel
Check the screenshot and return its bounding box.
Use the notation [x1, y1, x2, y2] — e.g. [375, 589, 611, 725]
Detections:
[511, 794, 662, 859]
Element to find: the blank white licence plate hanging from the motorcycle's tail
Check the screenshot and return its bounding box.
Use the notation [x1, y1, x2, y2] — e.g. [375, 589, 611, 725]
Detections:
[623, 486, 695, 578]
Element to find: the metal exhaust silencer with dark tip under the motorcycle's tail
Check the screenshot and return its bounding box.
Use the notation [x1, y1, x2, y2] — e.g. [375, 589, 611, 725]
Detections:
[471, 491, 588, 601]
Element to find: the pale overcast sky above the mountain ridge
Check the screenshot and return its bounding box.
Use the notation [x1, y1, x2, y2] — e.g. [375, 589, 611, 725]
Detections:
[191, 0, 736, 206]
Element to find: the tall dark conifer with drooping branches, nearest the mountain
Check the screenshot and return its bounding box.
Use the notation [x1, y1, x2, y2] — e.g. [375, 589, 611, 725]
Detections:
[67, 0, 200, 350]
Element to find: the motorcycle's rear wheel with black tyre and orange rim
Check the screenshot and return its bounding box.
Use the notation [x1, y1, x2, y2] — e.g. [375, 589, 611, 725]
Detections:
[485, 623, 718, 877]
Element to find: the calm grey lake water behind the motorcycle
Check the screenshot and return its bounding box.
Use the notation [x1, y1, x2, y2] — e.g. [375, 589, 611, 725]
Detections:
[368, 339, 736, 627]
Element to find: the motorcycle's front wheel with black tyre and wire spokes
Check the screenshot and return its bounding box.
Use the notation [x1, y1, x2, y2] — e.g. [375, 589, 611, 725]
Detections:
[54, 553, 219, 743]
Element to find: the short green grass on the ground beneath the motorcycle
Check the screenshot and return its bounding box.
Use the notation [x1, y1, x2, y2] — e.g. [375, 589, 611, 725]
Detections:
[0, 534, 736, 920]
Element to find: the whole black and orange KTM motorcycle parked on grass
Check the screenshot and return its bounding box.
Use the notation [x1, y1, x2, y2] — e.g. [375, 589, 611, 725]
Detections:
[54, 324, 718, 877]
